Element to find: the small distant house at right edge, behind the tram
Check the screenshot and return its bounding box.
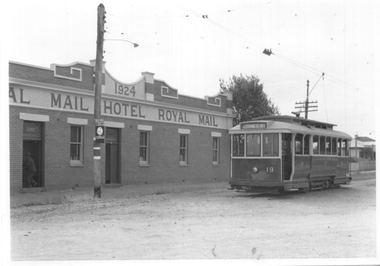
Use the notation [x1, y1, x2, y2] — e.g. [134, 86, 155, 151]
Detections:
[350, 136, 376, 160]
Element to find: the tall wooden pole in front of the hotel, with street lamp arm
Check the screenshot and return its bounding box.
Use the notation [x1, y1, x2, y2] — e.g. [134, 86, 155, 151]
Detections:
[94, 4, 105, 198]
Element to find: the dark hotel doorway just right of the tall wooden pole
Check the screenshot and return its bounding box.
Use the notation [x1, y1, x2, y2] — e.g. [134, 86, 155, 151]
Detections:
[106, 128, 120, 184]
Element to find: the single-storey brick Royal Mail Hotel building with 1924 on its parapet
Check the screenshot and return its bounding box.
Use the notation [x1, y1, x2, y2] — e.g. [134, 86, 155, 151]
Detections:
[9, 61, 234, 191]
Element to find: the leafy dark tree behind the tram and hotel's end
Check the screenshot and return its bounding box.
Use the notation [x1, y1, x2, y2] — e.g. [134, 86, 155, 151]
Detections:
[219, 75, 280, 125]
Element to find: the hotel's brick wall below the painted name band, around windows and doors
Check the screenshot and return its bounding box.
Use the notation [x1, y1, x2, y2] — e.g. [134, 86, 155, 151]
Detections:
[10, 104, 230, 190]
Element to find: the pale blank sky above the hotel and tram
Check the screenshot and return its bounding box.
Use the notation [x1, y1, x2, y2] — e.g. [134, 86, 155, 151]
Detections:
[2, 0, 380, 139]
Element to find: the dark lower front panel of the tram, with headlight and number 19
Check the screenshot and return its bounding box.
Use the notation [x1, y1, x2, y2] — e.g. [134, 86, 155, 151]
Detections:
[232, 159, 281, 181]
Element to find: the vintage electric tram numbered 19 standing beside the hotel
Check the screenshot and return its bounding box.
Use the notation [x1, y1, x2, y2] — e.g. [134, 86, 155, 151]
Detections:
[229, 116, 351, 193]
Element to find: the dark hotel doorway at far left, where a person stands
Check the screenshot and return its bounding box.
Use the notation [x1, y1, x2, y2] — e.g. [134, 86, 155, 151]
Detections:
[22, 121, 44, 188]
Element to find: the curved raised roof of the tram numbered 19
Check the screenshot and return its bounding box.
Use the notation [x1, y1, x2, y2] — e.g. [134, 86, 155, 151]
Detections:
[229, 115, 352, 139]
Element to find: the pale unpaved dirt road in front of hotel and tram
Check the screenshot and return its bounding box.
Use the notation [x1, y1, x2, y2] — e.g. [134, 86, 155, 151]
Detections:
[11, 173, 376, 261]
